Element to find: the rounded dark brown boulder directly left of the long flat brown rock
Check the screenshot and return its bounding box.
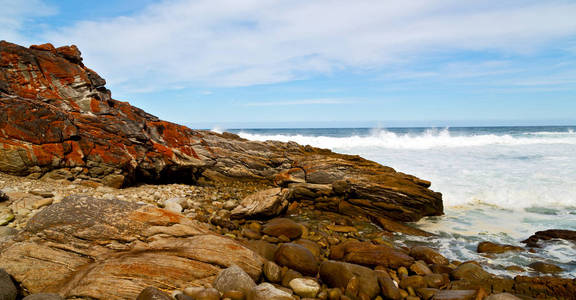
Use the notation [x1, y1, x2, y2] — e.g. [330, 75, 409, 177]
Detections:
[274, 243, 318, 276]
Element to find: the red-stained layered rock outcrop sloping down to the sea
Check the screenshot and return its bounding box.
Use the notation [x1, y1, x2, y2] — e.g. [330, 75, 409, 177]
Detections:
[0, 41, 443, 221]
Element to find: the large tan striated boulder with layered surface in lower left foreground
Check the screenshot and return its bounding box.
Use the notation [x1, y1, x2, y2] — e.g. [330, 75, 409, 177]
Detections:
[0, 197, 264, 299]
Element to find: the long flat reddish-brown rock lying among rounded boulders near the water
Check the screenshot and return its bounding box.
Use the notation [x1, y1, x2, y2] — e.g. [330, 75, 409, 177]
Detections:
[330, 241, 414, 268]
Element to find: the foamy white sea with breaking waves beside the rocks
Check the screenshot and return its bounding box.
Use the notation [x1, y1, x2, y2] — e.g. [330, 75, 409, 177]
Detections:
[229, 126, 576, 277]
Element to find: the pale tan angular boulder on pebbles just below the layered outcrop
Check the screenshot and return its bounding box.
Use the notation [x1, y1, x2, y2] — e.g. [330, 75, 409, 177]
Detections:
[232, 188, 289, 218]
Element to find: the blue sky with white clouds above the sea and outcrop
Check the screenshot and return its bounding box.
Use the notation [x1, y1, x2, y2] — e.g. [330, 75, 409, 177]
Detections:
[0, 0, 576, 129]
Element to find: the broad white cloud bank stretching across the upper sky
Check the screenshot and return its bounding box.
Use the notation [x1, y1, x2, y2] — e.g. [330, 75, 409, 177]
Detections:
[14, 0, 576, 91]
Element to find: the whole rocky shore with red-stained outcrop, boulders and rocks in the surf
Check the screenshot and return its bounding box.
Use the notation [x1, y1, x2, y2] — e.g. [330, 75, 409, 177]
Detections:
[0, 41, 576, 300]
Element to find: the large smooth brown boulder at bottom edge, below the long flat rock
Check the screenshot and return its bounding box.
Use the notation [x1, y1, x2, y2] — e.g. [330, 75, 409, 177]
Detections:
[320, 260, 380, 298]
